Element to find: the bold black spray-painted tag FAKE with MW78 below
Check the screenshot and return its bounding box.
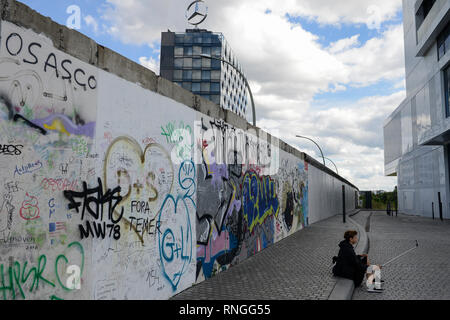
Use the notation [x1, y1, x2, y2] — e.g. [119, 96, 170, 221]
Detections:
[64, 178, 124, 240]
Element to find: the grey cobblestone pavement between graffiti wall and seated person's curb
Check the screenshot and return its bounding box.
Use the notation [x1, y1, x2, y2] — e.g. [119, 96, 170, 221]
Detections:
[172, 215, 355, 300]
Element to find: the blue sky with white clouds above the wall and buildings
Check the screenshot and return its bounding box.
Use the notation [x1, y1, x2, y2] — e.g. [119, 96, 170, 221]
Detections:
[17, 0, 405, 190]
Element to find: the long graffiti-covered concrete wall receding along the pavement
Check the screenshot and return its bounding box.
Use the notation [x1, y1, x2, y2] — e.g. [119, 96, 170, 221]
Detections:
[0, 1, 357, 300]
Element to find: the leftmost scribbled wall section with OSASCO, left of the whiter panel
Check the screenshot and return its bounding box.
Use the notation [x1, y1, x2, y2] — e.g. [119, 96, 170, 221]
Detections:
[0, 22, 98, 299]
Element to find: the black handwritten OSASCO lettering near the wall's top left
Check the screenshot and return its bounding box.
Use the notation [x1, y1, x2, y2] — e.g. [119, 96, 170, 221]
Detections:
[6, 32, 97, 90]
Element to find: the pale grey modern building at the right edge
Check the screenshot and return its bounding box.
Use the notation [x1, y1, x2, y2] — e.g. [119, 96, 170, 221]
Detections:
[384, 0, 450, 219]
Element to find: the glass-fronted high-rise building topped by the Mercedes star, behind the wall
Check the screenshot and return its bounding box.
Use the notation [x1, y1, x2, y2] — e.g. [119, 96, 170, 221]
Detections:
[160, 29, 248, 117]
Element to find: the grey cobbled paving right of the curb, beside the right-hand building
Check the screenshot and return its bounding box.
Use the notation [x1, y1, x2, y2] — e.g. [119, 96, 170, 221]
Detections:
[352, 211, 450, 300]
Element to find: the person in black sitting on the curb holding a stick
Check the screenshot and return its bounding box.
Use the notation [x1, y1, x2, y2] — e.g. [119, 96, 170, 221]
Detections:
[333, 230, 382, 292]
